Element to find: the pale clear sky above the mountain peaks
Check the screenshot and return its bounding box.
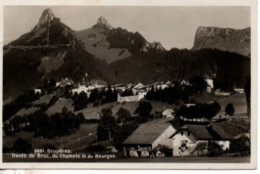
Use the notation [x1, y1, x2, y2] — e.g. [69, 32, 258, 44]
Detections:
[4, 6, 250, 49]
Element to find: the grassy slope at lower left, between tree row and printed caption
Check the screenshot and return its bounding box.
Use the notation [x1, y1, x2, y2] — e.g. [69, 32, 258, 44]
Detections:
[3, 124, 98, 152]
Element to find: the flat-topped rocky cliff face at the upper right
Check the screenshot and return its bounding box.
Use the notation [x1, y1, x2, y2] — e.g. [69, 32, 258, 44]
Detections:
[192, 27, 251, 56]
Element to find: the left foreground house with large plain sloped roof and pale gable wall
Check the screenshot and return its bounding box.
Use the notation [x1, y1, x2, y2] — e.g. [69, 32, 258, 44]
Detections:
[123, 118, 176, 157]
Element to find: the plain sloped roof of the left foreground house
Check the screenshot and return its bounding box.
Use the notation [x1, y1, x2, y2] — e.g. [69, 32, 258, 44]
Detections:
[123, 119, 171, 144]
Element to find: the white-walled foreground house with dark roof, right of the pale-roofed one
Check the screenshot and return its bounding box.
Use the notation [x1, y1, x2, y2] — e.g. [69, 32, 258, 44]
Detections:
[170, 122, 233, 156]
